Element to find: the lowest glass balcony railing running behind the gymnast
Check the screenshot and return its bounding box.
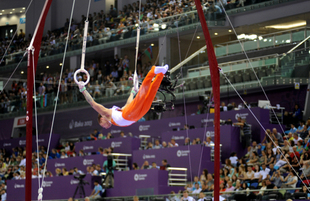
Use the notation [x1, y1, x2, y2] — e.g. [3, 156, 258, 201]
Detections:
[0, 48, 310, 118]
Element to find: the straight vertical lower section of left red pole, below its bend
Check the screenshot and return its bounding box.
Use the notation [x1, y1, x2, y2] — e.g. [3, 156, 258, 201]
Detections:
[25, 49, 33, 201]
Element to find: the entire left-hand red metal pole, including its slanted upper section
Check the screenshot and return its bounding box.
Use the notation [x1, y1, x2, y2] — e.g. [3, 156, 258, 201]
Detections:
[25, 0, 53, 201]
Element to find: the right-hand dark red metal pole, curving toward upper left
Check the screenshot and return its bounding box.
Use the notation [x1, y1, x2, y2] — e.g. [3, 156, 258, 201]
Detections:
[195, 0, 221, 201]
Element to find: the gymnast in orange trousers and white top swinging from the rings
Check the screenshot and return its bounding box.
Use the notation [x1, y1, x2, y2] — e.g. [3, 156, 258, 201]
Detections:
[77, 65, 168, 129]
